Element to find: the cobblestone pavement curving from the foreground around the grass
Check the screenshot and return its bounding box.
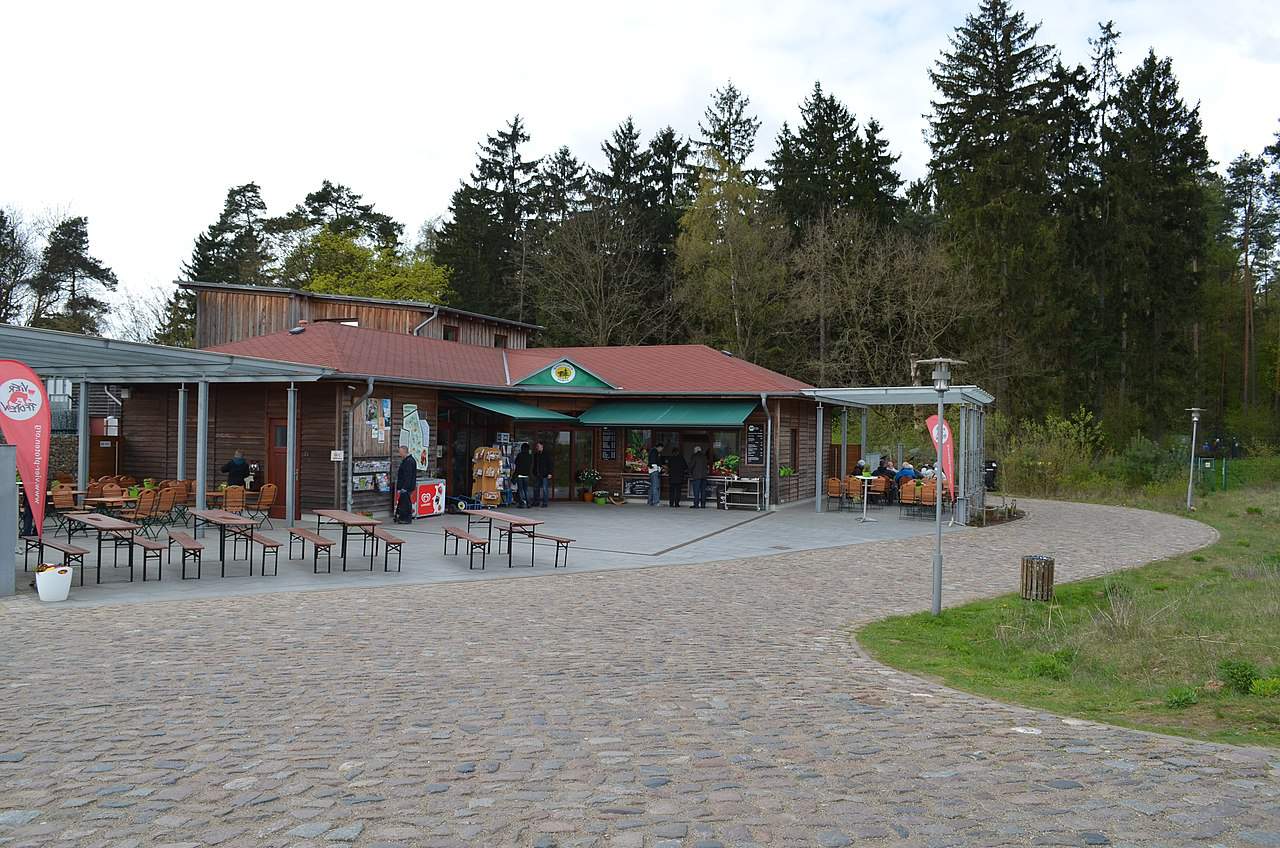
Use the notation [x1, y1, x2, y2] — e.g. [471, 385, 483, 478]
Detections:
[0, 503, 1280, 848]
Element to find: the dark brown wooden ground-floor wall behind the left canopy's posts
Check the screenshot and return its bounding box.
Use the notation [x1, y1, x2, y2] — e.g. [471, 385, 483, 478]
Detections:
[120, 383, 338, 510]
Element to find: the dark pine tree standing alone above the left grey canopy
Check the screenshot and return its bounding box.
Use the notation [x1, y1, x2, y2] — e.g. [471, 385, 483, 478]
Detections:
[31, 216, 116, 336]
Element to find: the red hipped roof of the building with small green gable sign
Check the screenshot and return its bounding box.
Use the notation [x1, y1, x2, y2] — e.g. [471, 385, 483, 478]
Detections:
[209, 322, 813, 395]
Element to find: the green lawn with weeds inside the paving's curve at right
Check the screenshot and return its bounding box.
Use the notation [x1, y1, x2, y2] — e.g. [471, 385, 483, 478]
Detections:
[858, 483, 1280, 747]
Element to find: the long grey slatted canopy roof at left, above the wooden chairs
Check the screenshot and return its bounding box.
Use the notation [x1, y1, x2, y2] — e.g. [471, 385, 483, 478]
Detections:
[0, 324, 333, 383]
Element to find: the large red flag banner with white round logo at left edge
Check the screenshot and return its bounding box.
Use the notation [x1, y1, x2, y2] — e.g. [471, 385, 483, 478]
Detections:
[0, 359, 50, 535]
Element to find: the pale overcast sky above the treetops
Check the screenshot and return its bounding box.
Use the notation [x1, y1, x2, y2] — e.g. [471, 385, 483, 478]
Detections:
[0, 0, 1280, 306]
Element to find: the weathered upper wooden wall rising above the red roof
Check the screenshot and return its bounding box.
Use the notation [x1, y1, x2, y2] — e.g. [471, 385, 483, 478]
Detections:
[196, 288, 529, 348]
